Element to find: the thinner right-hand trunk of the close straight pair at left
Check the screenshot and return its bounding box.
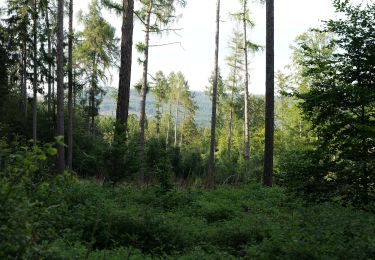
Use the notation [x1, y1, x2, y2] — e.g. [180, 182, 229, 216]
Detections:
[68, 0, 74, 170]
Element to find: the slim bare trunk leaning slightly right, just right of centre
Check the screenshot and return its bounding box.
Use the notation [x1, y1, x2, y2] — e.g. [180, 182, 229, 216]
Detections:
[207, 0, 220, 188]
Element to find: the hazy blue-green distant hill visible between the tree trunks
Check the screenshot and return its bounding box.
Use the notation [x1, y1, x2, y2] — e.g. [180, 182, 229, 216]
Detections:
[100, 88, 211, 127]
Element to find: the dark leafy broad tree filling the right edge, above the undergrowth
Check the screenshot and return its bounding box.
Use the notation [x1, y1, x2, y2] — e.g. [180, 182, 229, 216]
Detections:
[296, 0, 375, 204]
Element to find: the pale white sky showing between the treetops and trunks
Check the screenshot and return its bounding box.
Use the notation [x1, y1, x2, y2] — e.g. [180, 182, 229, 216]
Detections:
[0, 0, 348, 94]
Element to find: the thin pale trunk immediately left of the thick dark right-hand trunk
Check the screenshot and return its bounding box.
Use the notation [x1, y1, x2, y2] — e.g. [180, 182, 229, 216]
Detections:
[243, 0, 250, 173]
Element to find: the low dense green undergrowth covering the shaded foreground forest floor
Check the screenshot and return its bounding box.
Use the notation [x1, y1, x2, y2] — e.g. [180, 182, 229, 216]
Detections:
[0, 176, 375, 259]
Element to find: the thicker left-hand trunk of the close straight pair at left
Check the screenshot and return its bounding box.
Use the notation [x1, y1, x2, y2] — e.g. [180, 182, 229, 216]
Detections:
[56, 0, 65, 174]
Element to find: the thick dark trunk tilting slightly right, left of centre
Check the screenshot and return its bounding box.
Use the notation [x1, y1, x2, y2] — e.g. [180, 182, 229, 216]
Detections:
[116, 0, 134, 134]
